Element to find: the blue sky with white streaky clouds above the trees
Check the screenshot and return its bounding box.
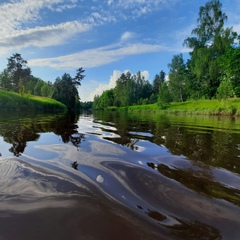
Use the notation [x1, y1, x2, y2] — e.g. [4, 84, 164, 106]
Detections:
[0, 0, 240, 101]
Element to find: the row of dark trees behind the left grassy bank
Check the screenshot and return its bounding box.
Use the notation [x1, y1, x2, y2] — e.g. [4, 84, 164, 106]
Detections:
[0, 53, 85, 110]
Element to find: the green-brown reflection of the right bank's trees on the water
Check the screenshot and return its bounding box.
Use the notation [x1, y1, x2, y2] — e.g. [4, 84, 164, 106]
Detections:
[94, 111, 240, 174]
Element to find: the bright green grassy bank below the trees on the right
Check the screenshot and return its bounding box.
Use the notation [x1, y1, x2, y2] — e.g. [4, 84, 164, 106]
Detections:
[108, 98, 240, 116]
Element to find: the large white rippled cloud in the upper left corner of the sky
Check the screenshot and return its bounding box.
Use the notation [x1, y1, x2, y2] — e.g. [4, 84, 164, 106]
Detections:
[0, 0, 92, 54]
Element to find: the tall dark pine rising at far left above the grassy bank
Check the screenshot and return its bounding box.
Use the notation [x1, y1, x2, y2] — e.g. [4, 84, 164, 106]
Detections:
[7, 53, 31, 92]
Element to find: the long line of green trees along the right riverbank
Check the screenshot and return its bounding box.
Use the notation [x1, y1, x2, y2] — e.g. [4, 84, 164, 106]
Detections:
[93, 0, 240, 109]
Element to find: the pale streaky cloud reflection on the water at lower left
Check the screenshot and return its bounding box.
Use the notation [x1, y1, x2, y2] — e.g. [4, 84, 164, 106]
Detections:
[0, 158, 88, 211]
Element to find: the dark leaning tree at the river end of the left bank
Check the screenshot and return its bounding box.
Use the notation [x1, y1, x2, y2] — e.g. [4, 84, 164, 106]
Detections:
[53, 68, 85, 110]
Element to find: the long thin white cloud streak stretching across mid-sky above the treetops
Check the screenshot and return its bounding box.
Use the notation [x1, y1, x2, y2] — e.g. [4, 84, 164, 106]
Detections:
[28, 43, 163, 70]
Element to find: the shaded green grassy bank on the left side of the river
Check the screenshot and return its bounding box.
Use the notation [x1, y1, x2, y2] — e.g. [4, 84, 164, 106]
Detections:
[0, 90, 67, 111]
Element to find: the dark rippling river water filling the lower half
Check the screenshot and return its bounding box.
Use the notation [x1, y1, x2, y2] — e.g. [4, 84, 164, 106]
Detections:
[0, 112, 240, 240]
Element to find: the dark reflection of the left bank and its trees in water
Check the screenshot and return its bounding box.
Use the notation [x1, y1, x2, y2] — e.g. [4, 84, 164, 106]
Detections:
[0, 110, 84, 157]
